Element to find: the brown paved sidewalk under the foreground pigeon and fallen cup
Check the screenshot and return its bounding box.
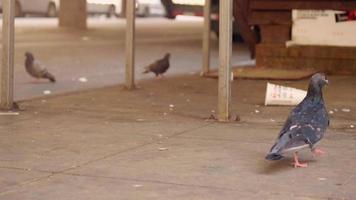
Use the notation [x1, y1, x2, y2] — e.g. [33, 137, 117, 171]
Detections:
[0, 75, 356, 200]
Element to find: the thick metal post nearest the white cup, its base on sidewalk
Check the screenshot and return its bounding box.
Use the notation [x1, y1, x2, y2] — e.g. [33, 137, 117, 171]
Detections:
[218, 0, 233, 121]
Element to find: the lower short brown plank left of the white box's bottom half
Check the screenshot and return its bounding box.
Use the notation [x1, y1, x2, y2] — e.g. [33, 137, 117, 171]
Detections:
[260, 25, 291, 43]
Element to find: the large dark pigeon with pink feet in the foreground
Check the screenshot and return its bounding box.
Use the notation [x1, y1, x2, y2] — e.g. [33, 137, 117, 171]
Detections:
[266, 73, 329, 168]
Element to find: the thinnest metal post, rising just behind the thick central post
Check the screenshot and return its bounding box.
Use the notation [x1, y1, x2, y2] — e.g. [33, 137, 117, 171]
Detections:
[201, 0, 211, 76]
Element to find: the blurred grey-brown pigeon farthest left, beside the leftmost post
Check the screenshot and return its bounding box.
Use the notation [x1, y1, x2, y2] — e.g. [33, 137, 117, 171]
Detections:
[25, 52, 56, 83]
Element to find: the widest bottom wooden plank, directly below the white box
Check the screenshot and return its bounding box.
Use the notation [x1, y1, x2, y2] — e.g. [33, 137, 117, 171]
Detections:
[256, 44, 356, 75]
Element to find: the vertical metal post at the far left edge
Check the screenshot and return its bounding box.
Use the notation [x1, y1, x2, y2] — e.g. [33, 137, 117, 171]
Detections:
[0, 0, 15, 110]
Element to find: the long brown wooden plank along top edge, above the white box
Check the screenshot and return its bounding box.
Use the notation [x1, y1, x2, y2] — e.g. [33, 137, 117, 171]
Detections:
[250, 0, 356, 10]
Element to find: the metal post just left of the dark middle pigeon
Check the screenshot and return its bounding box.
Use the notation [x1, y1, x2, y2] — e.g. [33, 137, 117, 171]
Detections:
[126, 0, 135, 89]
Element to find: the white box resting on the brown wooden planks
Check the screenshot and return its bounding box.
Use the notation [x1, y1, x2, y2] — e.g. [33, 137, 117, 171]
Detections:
[287, 10, 356, 47]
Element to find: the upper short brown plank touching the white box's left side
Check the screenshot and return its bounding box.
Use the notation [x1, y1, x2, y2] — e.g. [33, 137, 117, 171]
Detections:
[248, 11, 292, 25]
